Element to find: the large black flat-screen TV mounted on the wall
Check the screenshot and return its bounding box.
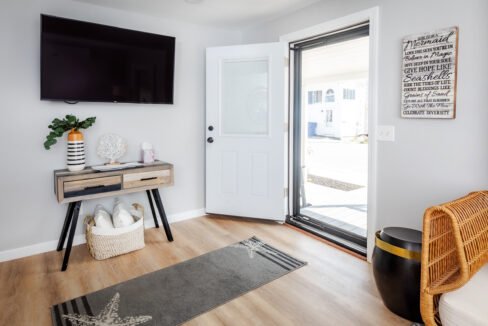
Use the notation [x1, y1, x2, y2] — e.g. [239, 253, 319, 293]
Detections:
[41, 15, 175, 104]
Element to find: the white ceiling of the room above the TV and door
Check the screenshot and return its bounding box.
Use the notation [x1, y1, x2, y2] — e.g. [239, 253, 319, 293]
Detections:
[76, 0, 321, 29]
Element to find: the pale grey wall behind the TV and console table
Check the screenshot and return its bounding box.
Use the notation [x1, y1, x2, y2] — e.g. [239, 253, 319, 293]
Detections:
[0, 0, 240, 256]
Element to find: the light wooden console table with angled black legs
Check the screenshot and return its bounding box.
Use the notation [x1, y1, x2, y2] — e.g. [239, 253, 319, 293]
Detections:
[54, 161, 173, 271]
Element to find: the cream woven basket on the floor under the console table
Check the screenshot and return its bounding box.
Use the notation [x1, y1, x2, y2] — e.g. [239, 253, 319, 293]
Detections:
[85, 204, 145, 260]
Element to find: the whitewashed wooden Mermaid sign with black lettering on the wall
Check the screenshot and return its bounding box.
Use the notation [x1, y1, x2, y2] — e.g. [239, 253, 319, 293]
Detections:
[402, 27, 458, 119]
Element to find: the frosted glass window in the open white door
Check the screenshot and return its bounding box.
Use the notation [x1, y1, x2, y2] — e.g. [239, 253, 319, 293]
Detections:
[220, 59, 269, 135]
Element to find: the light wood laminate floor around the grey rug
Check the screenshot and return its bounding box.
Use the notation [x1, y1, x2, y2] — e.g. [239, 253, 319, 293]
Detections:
[0, 216, 410, 326]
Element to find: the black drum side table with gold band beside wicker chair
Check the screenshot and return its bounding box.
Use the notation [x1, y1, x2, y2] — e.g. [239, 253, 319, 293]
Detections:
[373, 227, 422, 323]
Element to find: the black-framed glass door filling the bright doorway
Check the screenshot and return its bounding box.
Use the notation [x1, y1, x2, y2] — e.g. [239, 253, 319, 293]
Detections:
[291, 23, 369, 254]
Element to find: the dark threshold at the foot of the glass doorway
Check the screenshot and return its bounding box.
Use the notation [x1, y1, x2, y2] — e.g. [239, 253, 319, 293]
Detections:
[286, 216, 367, 260]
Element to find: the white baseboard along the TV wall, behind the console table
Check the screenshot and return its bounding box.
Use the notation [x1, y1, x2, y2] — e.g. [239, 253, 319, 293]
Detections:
[0, 208, 206, 262]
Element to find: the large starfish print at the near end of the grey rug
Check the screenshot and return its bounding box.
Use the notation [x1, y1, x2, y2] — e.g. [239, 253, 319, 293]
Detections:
[63, 292, 152, 326]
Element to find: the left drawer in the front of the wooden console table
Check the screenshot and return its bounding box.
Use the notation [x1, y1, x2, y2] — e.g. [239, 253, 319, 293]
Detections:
[63, 175, 122, 198]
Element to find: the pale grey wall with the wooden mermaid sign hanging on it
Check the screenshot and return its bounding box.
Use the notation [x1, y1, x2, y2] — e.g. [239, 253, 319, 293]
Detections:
[243, 0, 488, 234]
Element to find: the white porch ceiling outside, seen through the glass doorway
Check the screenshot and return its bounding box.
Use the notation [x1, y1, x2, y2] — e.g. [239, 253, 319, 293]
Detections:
[302, 37, 369, 82]
